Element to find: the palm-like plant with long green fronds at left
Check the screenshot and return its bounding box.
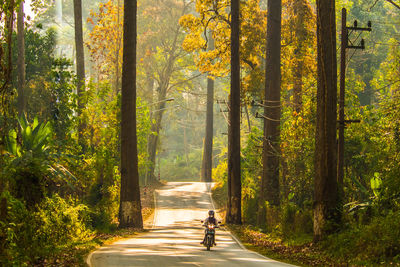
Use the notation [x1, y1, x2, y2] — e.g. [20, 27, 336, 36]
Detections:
[5, 115, 76, 204]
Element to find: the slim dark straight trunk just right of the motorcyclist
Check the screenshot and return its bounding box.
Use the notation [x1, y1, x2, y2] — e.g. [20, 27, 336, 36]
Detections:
[226, 0, 242, 224]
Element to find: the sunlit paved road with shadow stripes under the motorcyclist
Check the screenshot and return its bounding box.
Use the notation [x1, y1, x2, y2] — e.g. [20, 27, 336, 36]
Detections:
[88, 183, 290, 267]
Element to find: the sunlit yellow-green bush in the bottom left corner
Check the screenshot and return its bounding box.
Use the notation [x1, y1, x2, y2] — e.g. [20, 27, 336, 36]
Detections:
[0, 192, 91, 266]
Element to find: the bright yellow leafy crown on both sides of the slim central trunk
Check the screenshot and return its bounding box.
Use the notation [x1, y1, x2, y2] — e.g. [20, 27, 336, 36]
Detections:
[179, 0, 266, 94]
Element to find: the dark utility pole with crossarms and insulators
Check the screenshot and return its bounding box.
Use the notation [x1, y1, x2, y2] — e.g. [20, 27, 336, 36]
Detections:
[337, 8, 371, 197]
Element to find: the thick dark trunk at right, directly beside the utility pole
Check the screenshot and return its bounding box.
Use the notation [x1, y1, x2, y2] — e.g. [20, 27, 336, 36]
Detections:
[314, 0, 340, 241]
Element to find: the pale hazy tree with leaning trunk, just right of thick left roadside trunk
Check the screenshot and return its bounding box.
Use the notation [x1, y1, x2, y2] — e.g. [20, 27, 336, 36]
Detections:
[140, 0, 196, 183]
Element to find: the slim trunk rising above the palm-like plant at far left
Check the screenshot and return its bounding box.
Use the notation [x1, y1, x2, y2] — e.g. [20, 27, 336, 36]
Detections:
[17, 1, 27, 116]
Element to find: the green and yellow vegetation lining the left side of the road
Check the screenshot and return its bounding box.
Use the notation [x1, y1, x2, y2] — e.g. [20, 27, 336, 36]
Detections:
[0, 1, 161, 266]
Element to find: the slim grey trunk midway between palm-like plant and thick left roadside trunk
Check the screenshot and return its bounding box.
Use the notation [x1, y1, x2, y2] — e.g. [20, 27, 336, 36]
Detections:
[74, 0, 85, 145]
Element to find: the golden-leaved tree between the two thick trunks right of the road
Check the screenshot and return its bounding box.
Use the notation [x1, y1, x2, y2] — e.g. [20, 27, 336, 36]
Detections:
[280, 0, 317, 204]
